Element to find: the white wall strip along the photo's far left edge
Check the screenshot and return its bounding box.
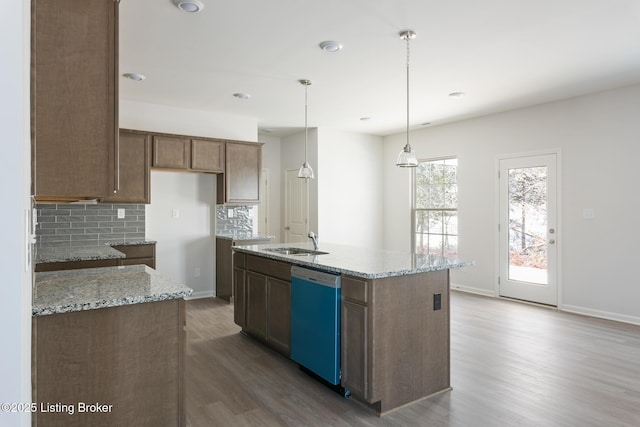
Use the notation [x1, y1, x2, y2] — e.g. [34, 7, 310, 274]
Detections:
[0, 1, 32, 426]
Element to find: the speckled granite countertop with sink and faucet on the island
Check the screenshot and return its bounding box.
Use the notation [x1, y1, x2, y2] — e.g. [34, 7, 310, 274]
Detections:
[233, 242, 474, 279]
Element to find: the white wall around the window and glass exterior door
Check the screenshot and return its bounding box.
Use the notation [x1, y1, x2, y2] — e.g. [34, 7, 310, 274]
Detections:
[384, 85, 640, 324]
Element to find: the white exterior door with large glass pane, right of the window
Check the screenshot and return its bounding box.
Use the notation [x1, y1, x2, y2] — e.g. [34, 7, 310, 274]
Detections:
[498, 153, 558, 306]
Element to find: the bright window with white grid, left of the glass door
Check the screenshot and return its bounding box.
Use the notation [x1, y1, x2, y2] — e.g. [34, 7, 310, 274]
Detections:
[413, 158, 458, 257]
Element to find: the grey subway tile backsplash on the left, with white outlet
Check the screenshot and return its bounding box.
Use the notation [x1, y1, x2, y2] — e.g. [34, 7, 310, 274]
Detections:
[36, 204, 145, 251]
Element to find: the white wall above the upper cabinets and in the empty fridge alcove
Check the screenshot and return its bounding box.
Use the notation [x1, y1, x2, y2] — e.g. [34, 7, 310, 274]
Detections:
[120, 100, 257, 298]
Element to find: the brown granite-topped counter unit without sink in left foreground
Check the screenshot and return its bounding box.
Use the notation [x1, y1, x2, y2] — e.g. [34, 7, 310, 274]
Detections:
[32, 265, 192, 426]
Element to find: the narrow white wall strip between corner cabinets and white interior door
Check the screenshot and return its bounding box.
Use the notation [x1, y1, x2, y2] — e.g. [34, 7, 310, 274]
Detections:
[258, 135, 284, 243]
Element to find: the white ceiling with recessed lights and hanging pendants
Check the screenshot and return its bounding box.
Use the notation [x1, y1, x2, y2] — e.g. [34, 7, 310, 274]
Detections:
[120, 0, 640, 135]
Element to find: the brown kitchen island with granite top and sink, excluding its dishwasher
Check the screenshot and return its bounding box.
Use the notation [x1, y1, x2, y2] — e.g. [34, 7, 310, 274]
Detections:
[234, 243, 473, 415]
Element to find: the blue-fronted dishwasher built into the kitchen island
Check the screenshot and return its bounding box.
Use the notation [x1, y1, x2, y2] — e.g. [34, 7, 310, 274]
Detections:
[290, 265, 340, 385]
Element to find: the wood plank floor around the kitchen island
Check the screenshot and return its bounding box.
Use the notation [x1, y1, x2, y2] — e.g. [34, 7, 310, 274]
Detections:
[186, 292, 640, 427]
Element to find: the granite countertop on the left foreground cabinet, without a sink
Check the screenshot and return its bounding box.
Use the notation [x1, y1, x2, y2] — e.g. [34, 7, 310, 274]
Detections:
[32, 265, 193, 316]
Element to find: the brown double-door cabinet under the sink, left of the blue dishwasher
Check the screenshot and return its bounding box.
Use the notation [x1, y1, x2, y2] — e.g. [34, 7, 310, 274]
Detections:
[233, 253, 291, 356]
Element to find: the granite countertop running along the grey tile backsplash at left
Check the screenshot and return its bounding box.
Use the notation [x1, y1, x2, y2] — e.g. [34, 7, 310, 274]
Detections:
[35, 240, 157, 264]
